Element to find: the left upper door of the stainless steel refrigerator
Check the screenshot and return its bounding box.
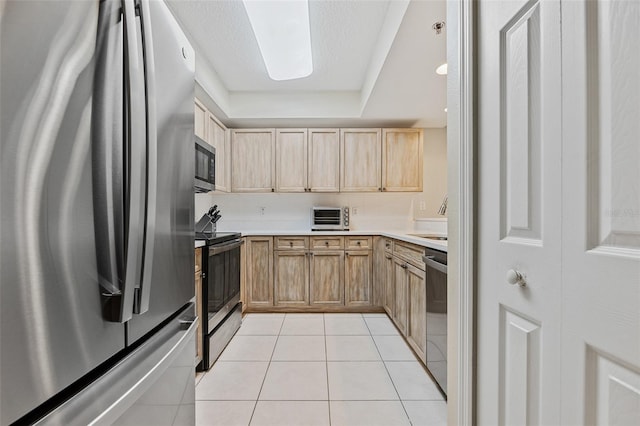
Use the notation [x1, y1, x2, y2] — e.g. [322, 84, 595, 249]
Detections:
[0, 1, 125, 425]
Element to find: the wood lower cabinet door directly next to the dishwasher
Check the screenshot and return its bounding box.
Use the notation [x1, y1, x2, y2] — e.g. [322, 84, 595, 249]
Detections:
[407, 264, 428, 364]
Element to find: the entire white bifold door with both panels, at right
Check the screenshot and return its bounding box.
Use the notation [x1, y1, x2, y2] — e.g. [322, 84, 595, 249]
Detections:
[476, 0, 640, 425]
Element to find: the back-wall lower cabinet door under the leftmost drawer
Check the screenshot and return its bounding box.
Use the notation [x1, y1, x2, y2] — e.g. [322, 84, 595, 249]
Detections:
[274, 250, 309, 306]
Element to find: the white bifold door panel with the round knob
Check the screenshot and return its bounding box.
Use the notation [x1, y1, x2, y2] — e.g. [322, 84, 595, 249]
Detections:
[476, 0, 562, 425]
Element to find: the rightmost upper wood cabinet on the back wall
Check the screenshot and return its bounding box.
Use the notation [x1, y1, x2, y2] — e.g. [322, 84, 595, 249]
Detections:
[382, 129, 424, 191]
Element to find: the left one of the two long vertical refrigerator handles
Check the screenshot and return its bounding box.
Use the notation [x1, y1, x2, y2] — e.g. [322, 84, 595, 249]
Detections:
[92, 0, 144, 322]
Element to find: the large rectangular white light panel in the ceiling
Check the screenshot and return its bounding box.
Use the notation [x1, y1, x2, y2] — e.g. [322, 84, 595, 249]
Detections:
[242, 0, 313, 81]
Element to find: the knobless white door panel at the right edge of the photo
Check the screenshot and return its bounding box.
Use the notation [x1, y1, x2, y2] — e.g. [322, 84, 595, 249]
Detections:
[562, 0, 640, 425]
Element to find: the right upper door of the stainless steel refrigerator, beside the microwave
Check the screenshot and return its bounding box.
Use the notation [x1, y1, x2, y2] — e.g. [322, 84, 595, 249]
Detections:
[128, 0, 195, 344]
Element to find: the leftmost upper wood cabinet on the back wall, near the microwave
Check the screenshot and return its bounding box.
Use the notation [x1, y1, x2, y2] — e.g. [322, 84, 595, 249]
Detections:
[231, 129, 275, 192]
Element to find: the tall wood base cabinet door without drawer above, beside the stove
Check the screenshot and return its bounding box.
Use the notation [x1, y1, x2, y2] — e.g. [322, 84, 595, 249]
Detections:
[245, 237, 273, 307]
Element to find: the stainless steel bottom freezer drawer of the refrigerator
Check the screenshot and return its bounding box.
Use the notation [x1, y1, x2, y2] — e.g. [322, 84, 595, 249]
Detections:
[36, 305, 197, 426]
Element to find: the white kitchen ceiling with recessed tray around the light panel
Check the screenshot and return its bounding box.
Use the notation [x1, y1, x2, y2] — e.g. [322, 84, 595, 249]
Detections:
[167, 0, 446, 127]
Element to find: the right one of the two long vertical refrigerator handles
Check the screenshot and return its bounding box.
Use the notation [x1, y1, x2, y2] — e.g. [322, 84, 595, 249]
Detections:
[134, 0, 158, 314]
